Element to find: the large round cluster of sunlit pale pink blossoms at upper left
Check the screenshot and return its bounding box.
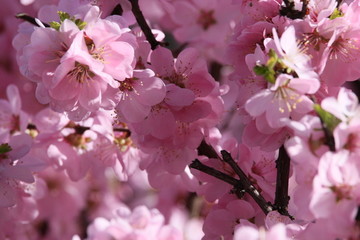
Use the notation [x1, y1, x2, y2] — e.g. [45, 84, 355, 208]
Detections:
[14, 4, 135, 121]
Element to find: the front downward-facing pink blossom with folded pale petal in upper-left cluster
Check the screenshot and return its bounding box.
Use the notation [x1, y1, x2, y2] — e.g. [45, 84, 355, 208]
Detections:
[49, 27, 132, 120]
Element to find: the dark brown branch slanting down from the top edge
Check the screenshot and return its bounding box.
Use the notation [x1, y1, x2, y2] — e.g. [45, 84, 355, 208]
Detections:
[129, 0, 160, 50]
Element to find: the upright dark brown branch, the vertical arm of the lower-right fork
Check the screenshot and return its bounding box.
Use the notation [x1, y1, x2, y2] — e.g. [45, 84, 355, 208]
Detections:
[274, 146, 293, 219]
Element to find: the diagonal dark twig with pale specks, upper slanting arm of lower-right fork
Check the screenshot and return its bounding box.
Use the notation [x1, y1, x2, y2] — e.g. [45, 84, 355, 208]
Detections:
[221, 150, 273, 214]
